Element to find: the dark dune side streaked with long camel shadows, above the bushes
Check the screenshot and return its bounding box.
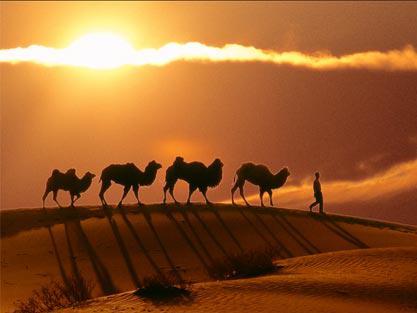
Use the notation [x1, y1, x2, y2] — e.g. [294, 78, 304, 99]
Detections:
[0, 205, 417, 312]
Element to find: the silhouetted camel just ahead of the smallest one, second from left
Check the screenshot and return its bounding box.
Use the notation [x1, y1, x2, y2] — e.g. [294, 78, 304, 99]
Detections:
[99, 161, 162, 208]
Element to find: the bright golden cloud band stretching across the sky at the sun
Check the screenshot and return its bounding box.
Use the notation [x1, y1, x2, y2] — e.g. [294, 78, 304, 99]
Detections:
[0, 35, 417, 71]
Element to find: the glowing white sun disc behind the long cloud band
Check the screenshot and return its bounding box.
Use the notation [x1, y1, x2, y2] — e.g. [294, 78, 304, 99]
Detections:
[65, 32, 135, 69]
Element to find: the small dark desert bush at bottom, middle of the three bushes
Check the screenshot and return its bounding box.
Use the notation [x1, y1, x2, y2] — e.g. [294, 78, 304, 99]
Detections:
[135, 275, 191, 301]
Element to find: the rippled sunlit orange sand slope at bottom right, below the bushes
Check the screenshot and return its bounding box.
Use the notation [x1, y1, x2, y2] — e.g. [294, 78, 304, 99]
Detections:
[57, 247, 417, 313]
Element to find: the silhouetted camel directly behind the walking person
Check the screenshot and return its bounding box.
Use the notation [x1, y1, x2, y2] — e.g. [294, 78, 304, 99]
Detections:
[231, 163, 290, 206]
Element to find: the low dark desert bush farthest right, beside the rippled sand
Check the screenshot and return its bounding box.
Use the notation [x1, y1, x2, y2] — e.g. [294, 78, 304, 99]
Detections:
[208, 249, 277, 279]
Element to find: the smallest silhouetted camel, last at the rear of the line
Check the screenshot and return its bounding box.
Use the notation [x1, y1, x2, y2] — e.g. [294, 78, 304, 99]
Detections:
[42, 168, 96, 208]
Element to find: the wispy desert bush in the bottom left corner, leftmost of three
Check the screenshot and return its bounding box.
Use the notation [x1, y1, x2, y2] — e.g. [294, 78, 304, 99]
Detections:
[14, 277, 94, 313]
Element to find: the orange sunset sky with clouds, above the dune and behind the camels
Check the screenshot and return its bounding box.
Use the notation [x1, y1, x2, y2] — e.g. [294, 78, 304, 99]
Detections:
[0, 1, 417, 224]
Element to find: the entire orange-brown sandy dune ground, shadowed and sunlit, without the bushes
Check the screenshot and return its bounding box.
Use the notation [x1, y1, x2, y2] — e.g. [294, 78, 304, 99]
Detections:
[1, 205, 417, 312]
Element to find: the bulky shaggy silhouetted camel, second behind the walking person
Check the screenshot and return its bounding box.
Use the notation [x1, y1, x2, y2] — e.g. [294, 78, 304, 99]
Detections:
[163, 157, 223, 204]
